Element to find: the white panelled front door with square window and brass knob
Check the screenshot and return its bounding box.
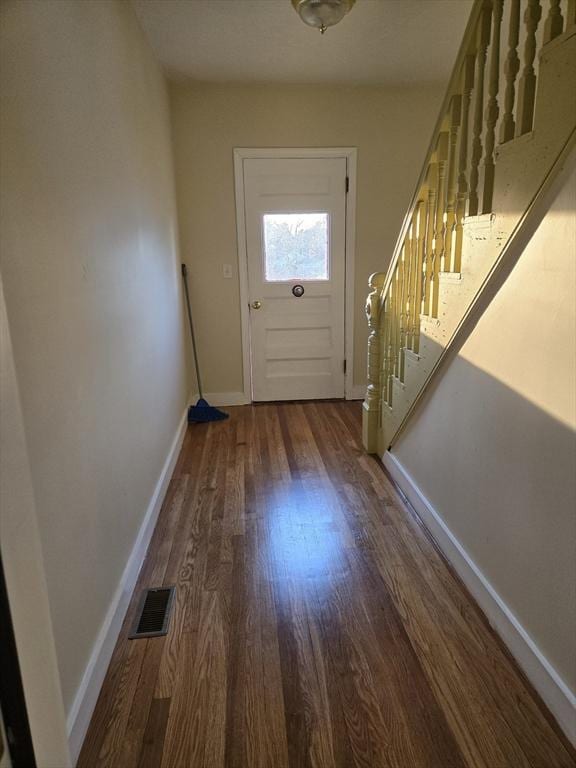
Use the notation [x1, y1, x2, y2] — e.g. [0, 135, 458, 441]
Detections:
[244, 158, 346, 400]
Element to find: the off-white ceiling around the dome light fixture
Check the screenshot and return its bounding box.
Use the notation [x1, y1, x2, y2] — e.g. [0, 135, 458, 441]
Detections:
[132, 0, 472, 85]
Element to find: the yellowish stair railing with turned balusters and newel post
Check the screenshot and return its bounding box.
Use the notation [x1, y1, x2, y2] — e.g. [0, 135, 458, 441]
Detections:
[364, 0, 576, 450]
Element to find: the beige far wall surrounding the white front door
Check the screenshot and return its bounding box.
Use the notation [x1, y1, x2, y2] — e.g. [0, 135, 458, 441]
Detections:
[170, 82, 443, 392]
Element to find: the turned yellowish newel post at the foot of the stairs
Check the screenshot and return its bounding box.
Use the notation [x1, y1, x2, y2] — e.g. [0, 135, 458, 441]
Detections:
[362, 272, 386, 453]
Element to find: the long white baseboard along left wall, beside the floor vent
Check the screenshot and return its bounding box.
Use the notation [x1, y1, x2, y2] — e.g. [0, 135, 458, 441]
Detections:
[67, 408, 188, 765]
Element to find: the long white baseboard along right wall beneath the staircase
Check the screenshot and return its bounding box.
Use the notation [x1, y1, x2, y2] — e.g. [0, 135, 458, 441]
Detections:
[382, 451, 576, 745]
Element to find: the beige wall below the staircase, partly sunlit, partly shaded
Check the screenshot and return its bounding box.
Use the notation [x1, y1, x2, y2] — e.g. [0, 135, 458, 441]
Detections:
[393, 165, 576, 691]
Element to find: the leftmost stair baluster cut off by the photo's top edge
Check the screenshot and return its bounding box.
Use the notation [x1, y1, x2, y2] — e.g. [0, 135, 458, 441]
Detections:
[481, 0, 504, 213]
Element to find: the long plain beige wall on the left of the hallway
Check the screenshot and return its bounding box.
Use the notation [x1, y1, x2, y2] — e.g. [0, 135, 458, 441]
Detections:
[0, 0, 187, 710]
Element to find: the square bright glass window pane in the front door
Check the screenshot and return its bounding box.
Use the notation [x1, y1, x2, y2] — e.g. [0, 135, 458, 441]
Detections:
[264, 213, 329, 282]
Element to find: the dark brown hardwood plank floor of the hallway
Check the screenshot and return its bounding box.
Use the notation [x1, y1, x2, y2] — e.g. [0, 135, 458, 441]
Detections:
[79, 402, 575, 768]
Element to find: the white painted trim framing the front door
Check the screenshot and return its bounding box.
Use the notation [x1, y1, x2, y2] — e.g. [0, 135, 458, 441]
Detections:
[234, 147, 364, 403]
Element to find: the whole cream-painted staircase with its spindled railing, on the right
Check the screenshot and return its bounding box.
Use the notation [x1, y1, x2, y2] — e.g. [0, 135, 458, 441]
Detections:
[363, 0, 576, 456]
